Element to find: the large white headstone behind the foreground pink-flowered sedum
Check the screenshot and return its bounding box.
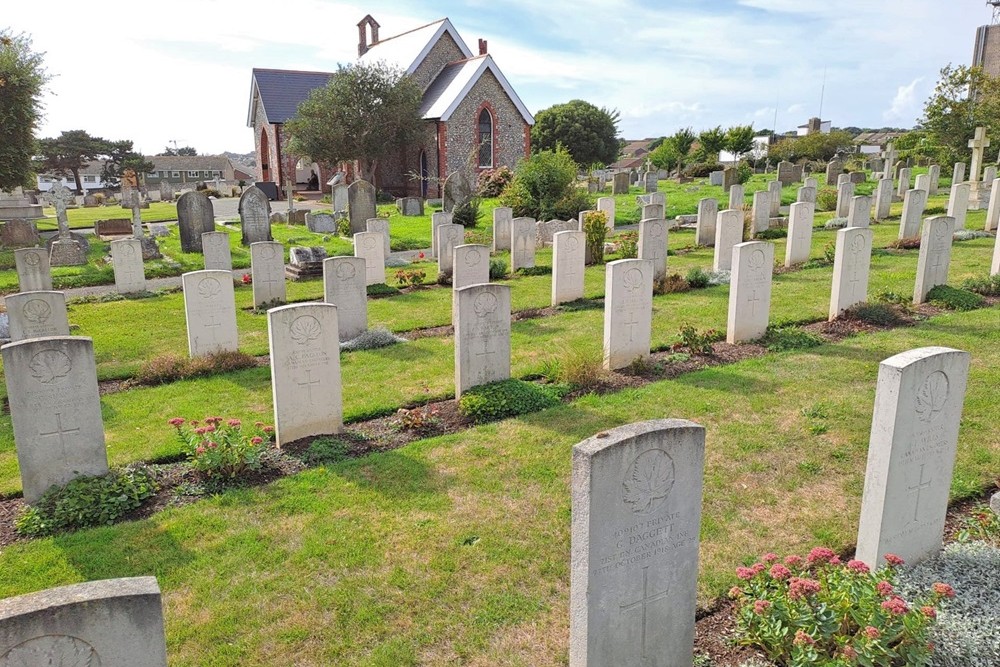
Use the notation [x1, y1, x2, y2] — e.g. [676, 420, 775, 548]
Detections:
[855, 347, 969, 569]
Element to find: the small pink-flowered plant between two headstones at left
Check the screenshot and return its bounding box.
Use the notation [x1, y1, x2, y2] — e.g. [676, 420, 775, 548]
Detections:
[169, 417, 274, 480]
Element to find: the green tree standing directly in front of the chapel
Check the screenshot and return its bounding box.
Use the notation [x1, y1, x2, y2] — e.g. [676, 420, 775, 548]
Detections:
[285, 62, 425, 182]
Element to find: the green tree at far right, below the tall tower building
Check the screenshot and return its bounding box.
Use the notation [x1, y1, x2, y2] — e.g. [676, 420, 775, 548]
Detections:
[920, 65, 1000, 163]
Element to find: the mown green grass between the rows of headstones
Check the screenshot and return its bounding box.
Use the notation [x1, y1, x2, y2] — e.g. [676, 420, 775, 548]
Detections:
[0, 172, 1000, 665]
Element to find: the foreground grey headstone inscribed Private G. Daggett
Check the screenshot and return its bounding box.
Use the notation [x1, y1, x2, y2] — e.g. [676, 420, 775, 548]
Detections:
[569, 419, 705, 667]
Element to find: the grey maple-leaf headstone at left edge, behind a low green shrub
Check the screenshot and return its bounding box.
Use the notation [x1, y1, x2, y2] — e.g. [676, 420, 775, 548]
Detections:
[0, 336, 108, 504]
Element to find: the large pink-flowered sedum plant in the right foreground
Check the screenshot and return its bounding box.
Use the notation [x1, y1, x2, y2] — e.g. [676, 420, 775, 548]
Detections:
[729, 547, 955, 667]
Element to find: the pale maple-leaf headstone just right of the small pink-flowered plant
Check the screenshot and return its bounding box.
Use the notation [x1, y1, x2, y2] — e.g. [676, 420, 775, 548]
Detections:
[266, 302, 344, 447]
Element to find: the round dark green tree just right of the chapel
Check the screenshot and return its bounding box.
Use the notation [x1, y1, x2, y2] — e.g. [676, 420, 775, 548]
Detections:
[531, 100, 619, 170]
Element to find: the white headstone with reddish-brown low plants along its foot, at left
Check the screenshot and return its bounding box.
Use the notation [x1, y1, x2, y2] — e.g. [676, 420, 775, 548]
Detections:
[181, 270, 239, 358]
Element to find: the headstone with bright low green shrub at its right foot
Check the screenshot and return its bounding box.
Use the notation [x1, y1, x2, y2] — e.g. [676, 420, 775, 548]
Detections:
[454, 283, 510, 399]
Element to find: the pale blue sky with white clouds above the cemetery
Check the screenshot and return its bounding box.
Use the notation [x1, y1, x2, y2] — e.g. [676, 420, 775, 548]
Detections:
[2, 0, 991, 153]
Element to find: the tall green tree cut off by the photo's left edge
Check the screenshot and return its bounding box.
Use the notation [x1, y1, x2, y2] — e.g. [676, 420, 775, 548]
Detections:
[0, 28, 49, 190]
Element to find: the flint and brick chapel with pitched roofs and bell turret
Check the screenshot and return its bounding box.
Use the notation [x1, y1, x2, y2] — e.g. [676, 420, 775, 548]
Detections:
[247, 15, 535, 198]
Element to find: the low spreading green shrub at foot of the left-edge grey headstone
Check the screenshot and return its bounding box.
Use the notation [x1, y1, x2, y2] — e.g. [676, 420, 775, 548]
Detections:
[14, 463, 159, 537]
